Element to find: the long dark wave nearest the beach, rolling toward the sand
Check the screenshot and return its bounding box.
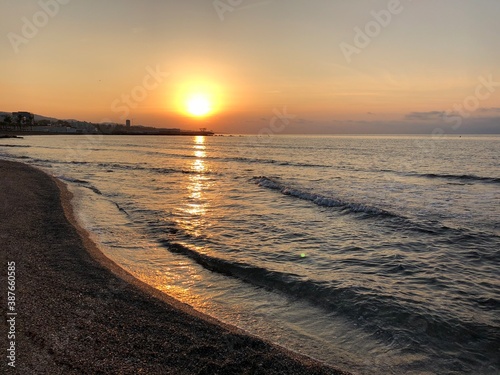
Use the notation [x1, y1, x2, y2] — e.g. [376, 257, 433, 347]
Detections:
[159, 239, 500, 362]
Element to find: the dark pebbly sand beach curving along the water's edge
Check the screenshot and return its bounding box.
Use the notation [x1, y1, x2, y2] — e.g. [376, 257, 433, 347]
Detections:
[0, 161, 352, 375]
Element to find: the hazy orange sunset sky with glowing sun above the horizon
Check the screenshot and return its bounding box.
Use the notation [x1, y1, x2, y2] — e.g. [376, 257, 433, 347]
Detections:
[0, 0, 500, 134]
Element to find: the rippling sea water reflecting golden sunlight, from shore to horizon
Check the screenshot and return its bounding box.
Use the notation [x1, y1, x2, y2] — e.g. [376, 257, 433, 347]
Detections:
[0, 136, 500, 374]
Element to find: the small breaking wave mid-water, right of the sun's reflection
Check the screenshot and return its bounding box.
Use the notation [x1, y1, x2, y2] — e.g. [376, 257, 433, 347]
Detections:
[253, 176, 405, 219]
